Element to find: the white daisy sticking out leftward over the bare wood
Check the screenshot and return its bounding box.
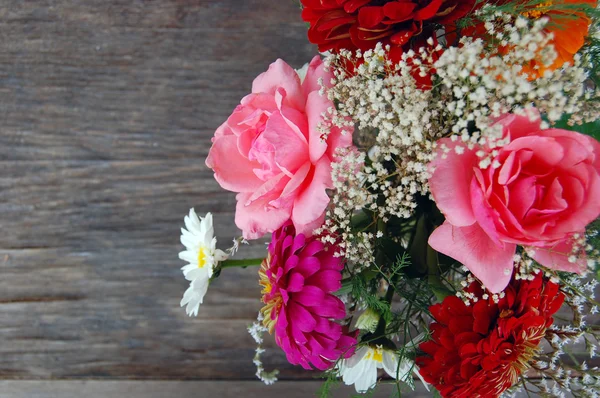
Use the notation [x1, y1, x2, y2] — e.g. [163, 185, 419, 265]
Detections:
[179, 209, 228, 316]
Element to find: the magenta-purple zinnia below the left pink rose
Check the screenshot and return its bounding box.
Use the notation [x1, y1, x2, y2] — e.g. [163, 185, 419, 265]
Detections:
[259, 222, 356, 370]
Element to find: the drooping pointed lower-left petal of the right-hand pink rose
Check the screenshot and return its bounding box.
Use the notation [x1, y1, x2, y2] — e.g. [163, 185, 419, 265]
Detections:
[429, 221, 517, 293]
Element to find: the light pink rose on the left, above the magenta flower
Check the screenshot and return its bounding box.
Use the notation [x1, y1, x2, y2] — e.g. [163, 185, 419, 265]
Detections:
[206, 56, 352, 239]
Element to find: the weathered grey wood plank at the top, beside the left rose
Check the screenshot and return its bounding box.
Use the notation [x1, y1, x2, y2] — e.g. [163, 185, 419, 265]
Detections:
[0, 0, 315, 160]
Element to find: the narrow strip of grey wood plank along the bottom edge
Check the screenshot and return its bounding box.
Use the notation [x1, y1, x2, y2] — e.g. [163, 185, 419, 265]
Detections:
[0, 380, 440, 398]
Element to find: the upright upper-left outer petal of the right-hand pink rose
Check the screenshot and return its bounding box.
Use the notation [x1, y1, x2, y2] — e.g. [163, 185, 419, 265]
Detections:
[429, 138, 478, 227]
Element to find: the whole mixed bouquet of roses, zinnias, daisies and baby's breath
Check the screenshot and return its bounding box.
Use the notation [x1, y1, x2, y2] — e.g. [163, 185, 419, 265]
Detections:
[179, 0, 600, 397]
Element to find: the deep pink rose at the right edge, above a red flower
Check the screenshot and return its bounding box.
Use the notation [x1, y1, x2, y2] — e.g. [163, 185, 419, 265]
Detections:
[429, 111, 600, 293]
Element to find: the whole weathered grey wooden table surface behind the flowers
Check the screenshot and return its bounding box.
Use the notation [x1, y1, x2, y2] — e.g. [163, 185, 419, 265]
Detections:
[0, 0, 440, 398]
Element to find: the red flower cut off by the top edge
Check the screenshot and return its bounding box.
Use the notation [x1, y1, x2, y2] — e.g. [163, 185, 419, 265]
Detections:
[302, 0, 475, 59]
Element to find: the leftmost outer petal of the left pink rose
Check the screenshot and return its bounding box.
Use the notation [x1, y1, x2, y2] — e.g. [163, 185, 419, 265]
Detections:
[206, 135, 262, 192]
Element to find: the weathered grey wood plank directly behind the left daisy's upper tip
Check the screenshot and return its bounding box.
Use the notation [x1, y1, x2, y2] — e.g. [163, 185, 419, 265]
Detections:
[0, 159, 245, 252]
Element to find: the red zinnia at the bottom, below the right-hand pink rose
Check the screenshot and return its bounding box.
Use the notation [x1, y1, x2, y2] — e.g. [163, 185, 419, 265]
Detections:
[416, 274, 564, 398]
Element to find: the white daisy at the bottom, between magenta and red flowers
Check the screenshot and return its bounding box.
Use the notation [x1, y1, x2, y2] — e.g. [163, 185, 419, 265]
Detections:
[338, 345, 429, 393]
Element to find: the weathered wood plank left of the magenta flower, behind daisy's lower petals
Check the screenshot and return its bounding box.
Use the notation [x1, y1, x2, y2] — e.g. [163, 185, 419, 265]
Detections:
[0, 247, 300, 379]
